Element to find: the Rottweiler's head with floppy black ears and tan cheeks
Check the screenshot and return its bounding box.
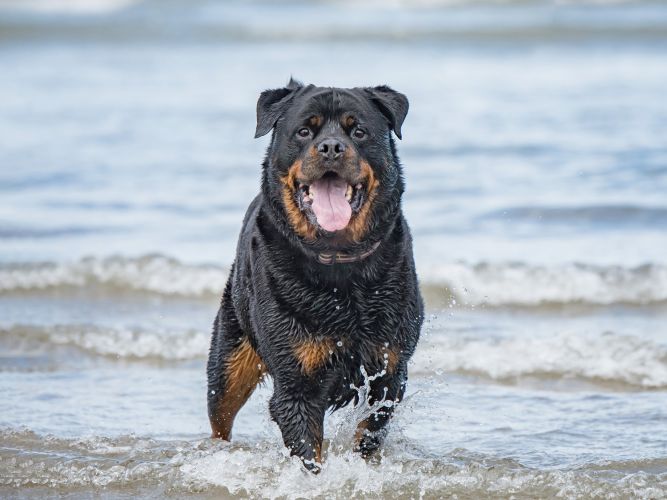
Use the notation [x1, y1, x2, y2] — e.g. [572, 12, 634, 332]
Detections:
[255, 80, 408, 248]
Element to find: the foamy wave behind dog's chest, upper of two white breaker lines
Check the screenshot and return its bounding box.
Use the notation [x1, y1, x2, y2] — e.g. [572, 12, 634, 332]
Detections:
[0, 255, 667, 307]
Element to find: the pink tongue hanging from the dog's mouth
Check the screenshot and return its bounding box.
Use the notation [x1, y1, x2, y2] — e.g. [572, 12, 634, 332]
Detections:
[310, 177, 352, 231]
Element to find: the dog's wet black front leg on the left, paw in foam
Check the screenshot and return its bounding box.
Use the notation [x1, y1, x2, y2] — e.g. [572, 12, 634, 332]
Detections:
[269, 374, 327, 473]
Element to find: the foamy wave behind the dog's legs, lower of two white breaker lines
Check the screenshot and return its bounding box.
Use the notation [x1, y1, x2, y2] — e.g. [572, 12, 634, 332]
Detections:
[0, 325, 667, 390]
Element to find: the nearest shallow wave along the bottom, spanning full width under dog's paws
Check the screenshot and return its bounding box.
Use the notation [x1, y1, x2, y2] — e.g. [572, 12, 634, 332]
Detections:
[0, 429, 667, 498]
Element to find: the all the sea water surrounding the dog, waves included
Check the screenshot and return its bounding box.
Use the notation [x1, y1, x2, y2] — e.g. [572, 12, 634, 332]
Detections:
[0, 0, 667, 498]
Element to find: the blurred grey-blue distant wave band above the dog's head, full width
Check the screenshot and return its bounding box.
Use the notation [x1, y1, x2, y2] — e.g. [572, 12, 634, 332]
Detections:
[0, 22, 667, 44]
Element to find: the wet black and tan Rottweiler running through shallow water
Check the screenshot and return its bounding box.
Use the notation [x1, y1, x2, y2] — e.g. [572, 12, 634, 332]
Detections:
[207, 81, 423, 471]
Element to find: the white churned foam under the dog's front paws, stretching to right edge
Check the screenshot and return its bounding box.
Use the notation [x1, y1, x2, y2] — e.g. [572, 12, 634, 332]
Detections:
[181, 447, 664, 499]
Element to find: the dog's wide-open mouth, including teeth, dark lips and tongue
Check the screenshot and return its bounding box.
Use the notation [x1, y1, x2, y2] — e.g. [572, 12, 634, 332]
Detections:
[296, 171, 366, 232]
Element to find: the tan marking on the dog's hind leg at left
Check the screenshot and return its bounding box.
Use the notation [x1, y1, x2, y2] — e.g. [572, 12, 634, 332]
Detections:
[211, 339, 266, 441]
